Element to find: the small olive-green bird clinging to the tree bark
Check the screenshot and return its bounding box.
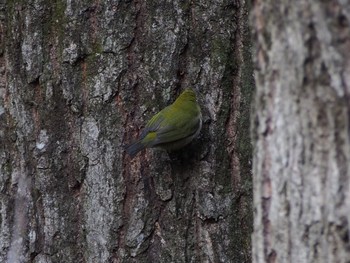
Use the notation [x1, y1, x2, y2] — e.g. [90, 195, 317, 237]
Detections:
[125, 89, 202, 158]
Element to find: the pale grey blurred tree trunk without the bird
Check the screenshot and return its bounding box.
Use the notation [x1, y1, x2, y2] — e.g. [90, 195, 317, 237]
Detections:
[252, 0, 350, 263]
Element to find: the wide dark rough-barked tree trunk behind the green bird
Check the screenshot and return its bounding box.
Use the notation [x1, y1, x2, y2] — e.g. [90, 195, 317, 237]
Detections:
[0, 0, 254, 263]
